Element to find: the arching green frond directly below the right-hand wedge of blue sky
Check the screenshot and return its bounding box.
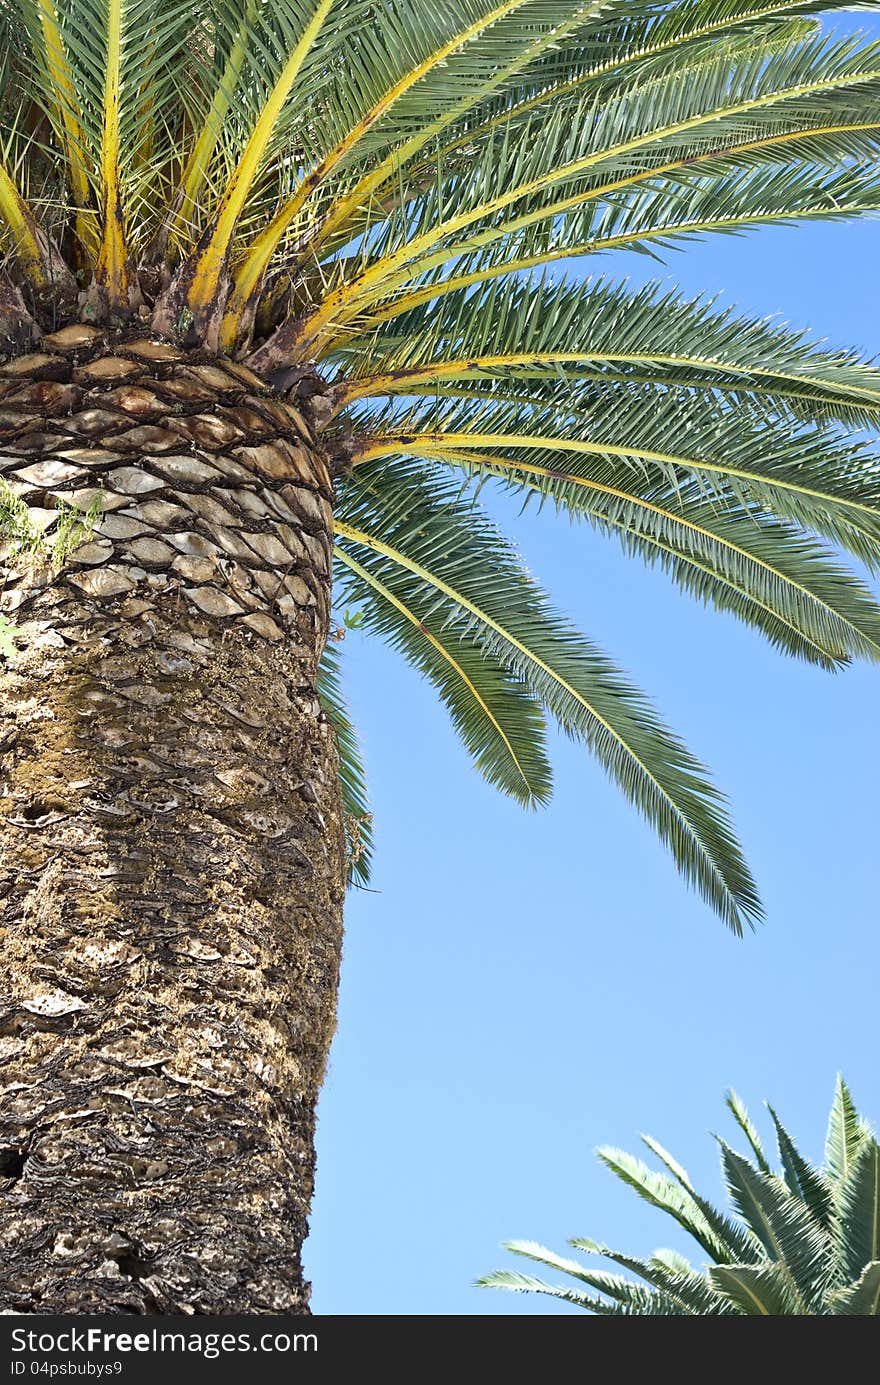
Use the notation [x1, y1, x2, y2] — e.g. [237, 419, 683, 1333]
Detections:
[340, 278, 880, 427]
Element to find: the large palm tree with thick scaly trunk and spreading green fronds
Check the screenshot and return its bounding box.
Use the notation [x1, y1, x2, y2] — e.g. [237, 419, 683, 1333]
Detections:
[0, 0, 880, 1313]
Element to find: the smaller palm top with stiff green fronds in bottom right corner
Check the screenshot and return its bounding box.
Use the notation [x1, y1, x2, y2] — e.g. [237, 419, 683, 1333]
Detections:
[477, 1078, 880, 1317]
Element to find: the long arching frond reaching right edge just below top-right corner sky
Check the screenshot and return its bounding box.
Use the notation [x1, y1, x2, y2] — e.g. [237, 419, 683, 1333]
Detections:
[284, 27, 880, 353]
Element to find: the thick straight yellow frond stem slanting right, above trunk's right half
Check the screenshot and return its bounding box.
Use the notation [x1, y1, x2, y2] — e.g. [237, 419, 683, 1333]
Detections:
[187, 0, 334, 324]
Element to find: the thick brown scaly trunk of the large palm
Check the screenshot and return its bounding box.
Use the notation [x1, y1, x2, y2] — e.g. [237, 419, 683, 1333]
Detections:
[0, 327, 345, 1313]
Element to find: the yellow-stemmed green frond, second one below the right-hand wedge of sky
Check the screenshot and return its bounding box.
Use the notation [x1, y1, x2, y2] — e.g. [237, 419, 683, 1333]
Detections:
[355, 382, 880, 564]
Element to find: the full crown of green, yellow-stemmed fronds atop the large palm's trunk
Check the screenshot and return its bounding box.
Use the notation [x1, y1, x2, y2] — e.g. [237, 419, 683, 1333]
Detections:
[0, 0, 880, 929]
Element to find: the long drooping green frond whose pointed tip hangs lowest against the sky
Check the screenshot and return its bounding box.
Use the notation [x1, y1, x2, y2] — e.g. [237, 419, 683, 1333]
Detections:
[337, 467, 759, 931]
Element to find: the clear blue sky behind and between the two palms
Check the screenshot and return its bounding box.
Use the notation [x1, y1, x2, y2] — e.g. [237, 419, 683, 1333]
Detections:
[306, 17, 880, 1316]
